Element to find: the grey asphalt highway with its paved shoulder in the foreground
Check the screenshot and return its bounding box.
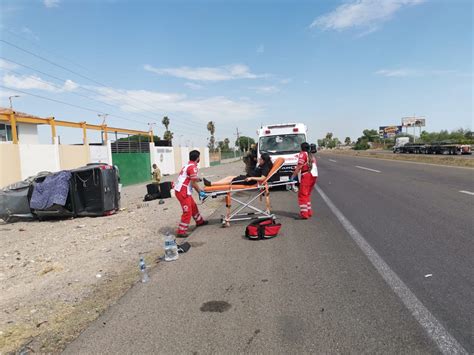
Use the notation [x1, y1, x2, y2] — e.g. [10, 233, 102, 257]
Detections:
[65, 154, 474, 354]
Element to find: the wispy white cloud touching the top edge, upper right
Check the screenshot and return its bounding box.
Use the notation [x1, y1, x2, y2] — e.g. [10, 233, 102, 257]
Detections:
[310, 0, 425, 34]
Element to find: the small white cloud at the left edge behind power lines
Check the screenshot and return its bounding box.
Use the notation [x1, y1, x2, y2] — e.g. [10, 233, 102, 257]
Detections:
[2, 74, 79, 93]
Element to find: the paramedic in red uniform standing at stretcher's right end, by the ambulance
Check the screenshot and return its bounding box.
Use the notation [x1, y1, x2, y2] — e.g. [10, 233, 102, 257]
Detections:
[291, 142, 317, 219]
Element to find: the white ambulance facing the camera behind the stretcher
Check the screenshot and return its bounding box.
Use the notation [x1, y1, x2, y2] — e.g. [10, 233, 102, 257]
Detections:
[257, 123, 308, 181]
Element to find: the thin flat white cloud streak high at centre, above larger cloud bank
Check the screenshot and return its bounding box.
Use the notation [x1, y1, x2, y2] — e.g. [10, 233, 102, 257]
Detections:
[144, 64, 266, 81]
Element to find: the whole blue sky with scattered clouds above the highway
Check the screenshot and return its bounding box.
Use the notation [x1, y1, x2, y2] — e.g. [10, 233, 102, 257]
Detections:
[0, 0, 473, 145]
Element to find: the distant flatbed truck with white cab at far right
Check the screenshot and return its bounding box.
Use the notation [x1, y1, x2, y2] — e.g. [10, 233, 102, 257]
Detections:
[393, 137, 472, 155]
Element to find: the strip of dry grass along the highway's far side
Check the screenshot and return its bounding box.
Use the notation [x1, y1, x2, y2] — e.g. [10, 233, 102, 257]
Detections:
[318, 149, 474, 168]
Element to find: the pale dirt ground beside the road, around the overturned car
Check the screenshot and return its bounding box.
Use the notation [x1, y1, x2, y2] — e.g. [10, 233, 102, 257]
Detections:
[0, 162, 244, 354]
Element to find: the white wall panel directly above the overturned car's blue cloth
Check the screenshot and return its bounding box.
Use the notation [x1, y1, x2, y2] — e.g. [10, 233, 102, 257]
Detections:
[18, 144, 61, 179]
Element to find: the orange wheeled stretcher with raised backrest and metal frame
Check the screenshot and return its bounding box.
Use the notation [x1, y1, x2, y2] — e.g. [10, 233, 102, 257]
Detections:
[204, 158, 296, 227]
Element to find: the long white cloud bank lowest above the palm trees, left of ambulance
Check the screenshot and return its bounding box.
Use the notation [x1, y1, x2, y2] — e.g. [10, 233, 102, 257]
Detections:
[96, 88, 262, 122]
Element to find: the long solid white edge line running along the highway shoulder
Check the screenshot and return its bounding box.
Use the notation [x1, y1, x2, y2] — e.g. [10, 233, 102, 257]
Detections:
[316, 186, 467, 354]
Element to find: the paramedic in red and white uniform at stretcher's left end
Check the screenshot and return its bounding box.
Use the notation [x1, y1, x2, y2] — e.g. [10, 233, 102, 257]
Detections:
[174, 150, 208, 238]
